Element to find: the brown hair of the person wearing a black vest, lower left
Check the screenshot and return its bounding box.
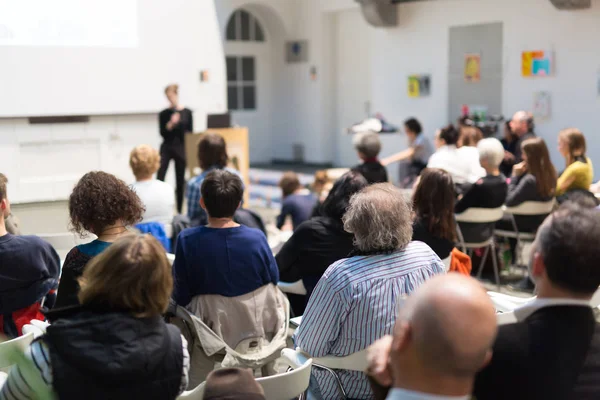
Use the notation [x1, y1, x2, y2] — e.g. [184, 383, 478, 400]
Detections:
[78, 234, 173, 318]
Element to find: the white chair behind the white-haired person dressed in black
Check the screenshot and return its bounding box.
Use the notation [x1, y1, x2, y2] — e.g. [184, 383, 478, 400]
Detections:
[455, 207, 504, 288]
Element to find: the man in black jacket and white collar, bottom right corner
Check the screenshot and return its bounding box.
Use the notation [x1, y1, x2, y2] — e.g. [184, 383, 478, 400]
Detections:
[474, 205, 600, 400]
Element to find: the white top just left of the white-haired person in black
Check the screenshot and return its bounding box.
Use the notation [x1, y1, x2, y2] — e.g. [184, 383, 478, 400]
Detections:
[427, 145, 485, 184]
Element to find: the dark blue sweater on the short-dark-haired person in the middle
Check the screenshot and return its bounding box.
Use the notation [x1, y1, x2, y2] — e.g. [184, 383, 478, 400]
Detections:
[173, 225, 279, 306]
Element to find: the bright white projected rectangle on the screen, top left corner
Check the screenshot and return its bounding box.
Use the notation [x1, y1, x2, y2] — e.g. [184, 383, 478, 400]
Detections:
[0, 0, 138, 48]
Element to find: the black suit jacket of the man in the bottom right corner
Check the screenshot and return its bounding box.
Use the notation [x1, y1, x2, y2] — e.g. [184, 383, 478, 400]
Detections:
[474, 306, 600, 400]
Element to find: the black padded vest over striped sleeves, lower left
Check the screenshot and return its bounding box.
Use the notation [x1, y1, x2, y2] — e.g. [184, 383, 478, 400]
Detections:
[41, 307, 183, 400]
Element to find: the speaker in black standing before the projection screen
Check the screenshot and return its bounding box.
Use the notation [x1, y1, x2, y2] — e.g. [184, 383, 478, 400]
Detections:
[156, 85, 194, 213]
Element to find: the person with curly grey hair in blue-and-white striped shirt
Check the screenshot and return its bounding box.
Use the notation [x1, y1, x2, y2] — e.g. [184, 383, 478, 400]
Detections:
[295, 183, 444, 399]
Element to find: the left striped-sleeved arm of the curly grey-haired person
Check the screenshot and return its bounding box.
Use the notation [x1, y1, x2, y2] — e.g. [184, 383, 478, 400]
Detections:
[295, 275, 346, 357]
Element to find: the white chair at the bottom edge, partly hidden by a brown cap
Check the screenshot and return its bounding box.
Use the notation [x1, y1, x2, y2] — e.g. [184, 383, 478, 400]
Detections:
[177, 349, 313, 400]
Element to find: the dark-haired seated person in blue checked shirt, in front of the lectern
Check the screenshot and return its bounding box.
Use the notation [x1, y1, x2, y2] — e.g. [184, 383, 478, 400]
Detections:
[186, 133, 242, 226]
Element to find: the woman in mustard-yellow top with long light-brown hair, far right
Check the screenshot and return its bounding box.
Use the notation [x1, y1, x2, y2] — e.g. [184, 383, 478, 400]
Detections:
[556, 128, 594, 196]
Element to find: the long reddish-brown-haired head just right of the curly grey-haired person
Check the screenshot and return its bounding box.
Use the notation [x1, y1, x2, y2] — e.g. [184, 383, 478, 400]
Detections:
[413, 168, 456, 241]
